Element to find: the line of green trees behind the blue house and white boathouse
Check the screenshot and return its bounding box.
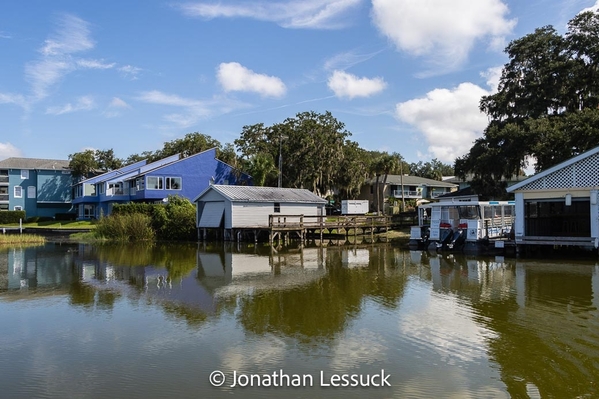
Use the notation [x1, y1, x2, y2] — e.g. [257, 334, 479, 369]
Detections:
[69, 111, 453, 198]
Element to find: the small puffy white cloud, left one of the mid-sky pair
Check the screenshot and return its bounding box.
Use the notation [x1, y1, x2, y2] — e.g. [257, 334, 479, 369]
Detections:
[217, 62, 287, 97]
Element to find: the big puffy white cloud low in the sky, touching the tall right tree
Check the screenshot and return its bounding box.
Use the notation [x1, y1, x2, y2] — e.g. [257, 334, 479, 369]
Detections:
[396, 83, 490, 162]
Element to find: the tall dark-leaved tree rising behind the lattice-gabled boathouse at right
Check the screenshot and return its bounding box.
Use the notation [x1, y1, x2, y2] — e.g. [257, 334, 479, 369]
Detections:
[455, 12, 599, 198]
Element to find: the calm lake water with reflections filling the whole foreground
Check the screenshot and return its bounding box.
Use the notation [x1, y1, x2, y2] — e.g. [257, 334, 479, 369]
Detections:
[0, 244, 599, 399]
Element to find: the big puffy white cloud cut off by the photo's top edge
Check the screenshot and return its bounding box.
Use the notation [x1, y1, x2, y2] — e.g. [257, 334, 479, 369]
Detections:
[372, 0, 516, 69]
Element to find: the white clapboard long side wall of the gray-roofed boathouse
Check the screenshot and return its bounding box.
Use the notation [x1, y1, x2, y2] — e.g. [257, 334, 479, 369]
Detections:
[227, 202, 318, 228]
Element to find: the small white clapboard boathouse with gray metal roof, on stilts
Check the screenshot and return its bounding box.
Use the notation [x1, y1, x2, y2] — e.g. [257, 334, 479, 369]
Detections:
[194, 185, 327, 230]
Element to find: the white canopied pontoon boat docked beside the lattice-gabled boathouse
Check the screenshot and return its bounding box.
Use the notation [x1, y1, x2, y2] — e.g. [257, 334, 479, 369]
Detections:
[410, 199, 515, 251]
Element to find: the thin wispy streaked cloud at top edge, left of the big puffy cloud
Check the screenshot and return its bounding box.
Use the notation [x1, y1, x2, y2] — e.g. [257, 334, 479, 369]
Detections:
[178, 0, 362, 29]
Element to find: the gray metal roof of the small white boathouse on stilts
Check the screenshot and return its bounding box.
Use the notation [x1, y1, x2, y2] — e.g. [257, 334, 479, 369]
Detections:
[194, 184, 327, 204]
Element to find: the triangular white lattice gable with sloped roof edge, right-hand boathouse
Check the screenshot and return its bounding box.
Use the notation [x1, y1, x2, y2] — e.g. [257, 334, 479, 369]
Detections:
[507, 147, 599, 193]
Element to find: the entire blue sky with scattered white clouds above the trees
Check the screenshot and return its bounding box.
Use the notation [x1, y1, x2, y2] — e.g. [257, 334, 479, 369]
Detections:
[0, 0, 599, 164]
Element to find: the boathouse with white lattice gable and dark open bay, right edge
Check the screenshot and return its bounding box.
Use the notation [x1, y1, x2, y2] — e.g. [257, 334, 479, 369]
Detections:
[507, 147, 599, 248]
